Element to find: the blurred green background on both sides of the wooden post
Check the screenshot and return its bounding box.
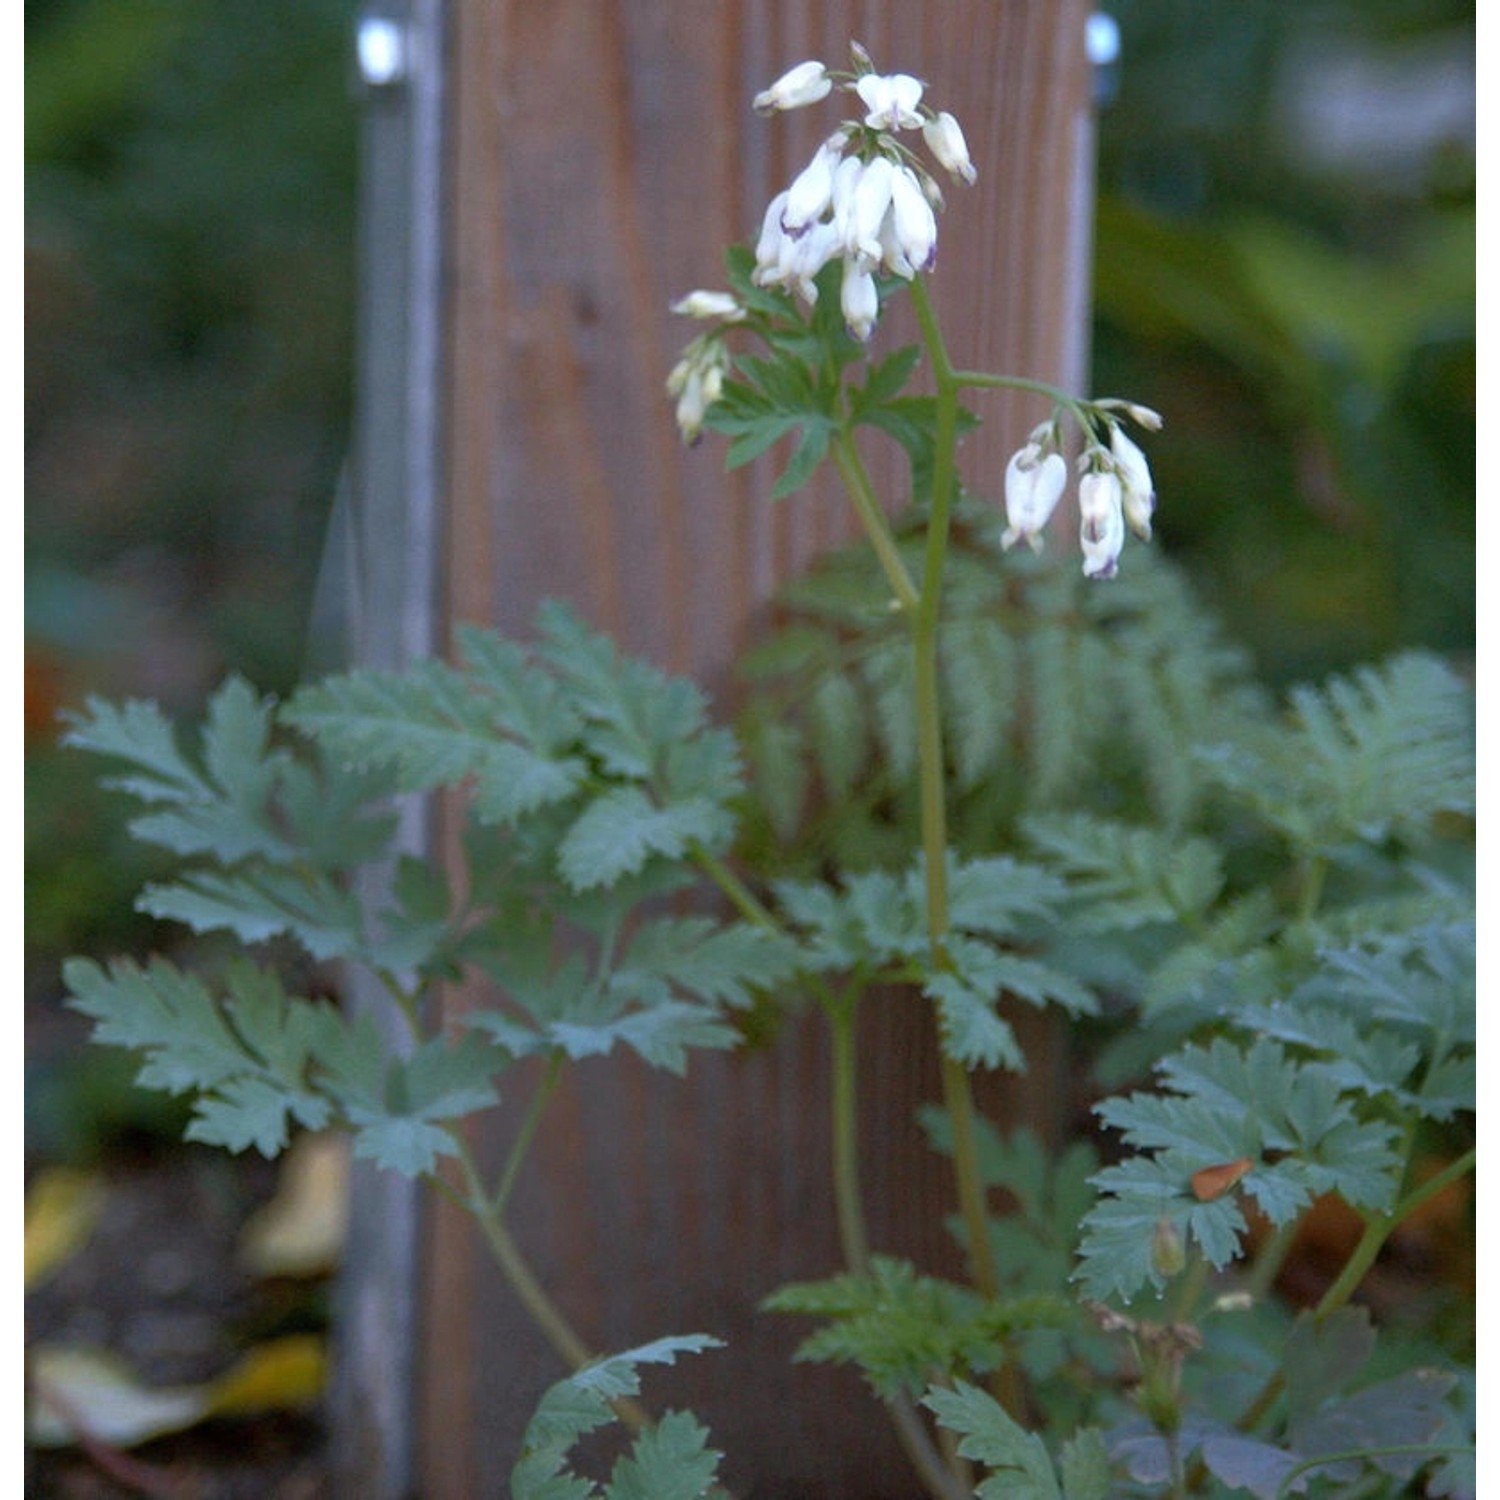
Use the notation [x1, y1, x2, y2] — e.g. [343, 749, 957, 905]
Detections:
[26, 0, 1476, 1151]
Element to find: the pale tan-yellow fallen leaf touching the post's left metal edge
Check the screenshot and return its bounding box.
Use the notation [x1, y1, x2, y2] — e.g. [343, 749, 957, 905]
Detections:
[240, 1134, 350, 1277]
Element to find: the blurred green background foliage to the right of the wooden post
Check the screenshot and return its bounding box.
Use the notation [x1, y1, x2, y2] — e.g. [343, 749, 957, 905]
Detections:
[1095, 0, 1476, 681]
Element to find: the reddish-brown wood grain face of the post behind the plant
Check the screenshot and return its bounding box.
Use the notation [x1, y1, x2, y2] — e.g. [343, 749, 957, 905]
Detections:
[422, 0, 1091, 1500]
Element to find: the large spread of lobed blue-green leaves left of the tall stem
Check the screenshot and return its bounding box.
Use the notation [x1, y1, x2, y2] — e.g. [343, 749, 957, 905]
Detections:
[68, 606, 797, 1175]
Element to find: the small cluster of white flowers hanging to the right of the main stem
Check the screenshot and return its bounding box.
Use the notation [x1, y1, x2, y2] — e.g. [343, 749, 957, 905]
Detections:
[1001, 401, 1161, 578]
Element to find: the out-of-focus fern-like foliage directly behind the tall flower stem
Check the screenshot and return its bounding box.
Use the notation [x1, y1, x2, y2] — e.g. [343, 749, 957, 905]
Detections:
[741, 531, 1266, 869]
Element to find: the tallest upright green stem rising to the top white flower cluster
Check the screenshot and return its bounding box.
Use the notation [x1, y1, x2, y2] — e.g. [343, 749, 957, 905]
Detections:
[911, 276, 1001, 1298]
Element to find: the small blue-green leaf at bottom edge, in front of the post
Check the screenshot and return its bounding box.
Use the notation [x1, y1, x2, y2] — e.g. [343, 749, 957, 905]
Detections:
[510, 1334, 720, 1500]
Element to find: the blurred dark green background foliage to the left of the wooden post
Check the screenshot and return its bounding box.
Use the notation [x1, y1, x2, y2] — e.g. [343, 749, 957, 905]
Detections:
[26, 0, 357, 1008]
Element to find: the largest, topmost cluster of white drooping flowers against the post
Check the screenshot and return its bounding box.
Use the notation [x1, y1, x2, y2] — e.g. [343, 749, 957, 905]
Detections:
[755, 47, 975, 341]
